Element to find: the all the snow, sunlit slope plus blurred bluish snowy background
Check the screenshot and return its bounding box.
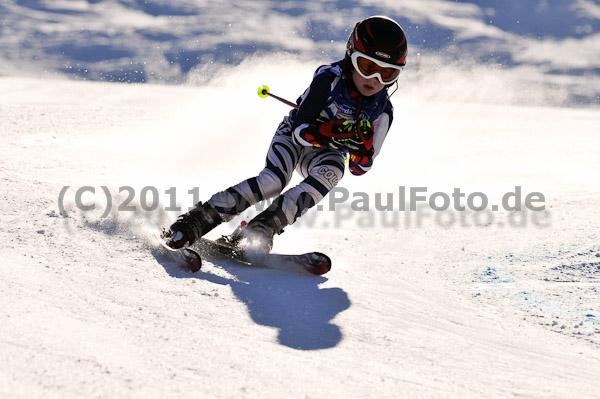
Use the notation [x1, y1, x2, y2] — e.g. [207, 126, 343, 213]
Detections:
[0, 0, 600, 398]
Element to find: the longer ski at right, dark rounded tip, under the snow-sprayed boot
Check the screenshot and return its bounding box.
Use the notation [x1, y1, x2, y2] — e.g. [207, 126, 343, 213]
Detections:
[191, 238, 331, 275]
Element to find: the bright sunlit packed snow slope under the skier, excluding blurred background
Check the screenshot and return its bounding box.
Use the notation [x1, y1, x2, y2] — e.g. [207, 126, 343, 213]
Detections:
[0, 54, 600, 398]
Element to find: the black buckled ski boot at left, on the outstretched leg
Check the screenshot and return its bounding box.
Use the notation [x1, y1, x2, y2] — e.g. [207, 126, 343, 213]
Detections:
[167, 202, 223, 249]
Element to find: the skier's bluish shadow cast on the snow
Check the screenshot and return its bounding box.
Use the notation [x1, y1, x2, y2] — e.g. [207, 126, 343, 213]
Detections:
[154, 251, 350, 350]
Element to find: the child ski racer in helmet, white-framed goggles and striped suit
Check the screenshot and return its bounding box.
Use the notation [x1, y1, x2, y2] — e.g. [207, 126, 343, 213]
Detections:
[167, 16, 407, 251]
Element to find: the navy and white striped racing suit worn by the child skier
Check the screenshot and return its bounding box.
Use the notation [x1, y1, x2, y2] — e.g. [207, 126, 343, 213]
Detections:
[208, 61, 393, 224]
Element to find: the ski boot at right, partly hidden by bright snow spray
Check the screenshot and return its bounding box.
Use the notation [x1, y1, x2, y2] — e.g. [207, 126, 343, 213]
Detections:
[217, 208, 288, 253]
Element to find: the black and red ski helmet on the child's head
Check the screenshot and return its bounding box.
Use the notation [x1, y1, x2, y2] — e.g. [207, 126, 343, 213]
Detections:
[346, 16, 408, 66]
